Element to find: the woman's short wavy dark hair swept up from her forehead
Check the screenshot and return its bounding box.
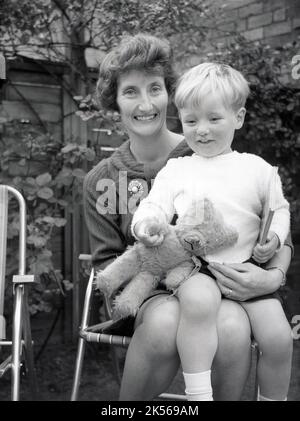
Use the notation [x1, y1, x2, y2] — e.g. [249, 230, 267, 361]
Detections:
[97, 33, 177, 111]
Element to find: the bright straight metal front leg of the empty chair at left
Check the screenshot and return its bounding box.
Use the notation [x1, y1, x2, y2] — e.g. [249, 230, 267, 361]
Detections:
[11, 285, 24, 401]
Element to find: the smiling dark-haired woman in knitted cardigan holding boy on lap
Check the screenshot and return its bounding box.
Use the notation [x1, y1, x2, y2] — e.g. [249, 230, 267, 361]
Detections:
[84, 34, 291, 400]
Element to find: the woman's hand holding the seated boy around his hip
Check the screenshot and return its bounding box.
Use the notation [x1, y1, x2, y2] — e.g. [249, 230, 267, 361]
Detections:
[208, 263, 282, 301]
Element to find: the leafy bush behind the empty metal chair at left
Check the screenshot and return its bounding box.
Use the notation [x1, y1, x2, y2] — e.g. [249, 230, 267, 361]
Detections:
[0, 122, 95, 314]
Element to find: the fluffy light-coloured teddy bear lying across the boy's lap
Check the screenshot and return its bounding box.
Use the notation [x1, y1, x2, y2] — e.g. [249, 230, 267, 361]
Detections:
[95, 199, 238, 318]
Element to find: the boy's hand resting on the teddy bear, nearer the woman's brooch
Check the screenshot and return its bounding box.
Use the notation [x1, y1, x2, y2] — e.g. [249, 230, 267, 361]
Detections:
[134, 218, 166, 247]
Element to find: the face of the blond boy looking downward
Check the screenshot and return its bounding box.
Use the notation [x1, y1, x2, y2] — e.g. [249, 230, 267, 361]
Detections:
[180, 94, 246, 158]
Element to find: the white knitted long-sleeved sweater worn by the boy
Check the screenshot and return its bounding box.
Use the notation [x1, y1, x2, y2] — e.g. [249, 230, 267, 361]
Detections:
[132, 151, 290, 263]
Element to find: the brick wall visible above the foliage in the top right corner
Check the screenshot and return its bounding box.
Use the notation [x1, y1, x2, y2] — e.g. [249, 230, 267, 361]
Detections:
[209, 0, 300, 45]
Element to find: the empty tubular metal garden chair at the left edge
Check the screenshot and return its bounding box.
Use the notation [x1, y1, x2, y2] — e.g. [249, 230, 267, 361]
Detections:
[0, 185, 37, 401]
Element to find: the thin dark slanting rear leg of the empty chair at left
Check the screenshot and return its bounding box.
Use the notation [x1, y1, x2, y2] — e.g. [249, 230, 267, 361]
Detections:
[23, 290, 38, 401]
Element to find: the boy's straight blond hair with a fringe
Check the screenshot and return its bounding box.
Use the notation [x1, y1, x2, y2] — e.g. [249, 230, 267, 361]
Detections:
[175, 63, 250, 111]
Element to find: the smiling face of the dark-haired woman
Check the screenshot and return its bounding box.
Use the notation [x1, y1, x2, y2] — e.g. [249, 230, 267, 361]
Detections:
[117, 70, 168, 137]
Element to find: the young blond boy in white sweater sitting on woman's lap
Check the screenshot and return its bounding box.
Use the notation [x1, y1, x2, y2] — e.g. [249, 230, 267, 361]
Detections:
[132, 63, 292, 400]
